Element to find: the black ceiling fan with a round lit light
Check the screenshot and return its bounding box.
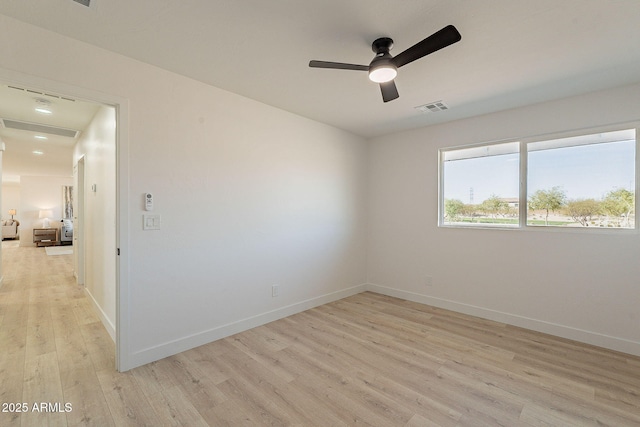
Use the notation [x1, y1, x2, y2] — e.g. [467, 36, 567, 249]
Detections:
[309, 25, 462, 102]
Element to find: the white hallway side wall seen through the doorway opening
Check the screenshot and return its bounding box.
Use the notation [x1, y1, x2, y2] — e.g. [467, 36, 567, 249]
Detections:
[73, 106, 116, 339]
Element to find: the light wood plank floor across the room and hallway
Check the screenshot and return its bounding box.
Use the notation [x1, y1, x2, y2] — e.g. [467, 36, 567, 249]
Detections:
[0, 242, 640, 426]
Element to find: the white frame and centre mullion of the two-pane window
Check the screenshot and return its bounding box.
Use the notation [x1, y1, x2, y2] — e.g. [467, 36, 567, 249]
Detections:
[437, 121, 640, 234]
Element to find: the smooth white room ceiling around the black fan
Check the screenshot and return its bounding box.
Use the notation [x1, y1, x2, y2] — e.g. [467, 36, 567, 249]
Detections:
[0, 0, 640, 137]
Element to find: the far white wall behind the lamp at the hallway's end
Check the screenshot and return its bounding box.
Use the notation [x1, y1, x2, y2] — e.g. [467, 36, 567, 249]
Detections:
[17, 175, 73, 246]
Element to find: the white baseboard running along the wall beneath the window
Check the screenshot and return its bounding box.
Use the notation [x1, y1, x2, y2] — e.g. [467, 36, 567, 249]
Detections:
[366, 283, 640, 356]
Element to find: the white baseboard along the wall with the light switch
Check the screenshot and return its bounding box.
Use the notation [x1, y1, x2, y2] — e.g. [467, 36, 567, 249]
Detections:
[128, 284, 366, 369]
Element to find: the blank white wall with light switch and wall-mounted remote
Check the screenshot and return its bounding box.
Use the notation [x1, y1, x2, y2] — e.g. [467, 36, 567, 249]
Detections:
[0, 15, 366, 369]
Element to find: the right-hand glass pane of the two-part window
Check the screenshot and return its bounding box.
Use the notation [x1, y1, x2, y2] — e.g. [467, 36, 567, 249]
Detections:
[527, 129, 636, 228]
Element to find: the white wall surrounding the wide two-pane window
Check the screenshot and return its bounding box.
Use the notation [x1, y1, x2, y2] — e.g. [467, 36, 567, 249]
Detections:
[368, 85, 640, 354]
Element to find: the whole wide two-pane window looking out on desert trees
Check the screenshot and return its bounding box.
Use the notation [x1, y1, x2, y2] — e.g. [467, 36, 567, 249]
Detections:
[440, 125, 637, 229]
